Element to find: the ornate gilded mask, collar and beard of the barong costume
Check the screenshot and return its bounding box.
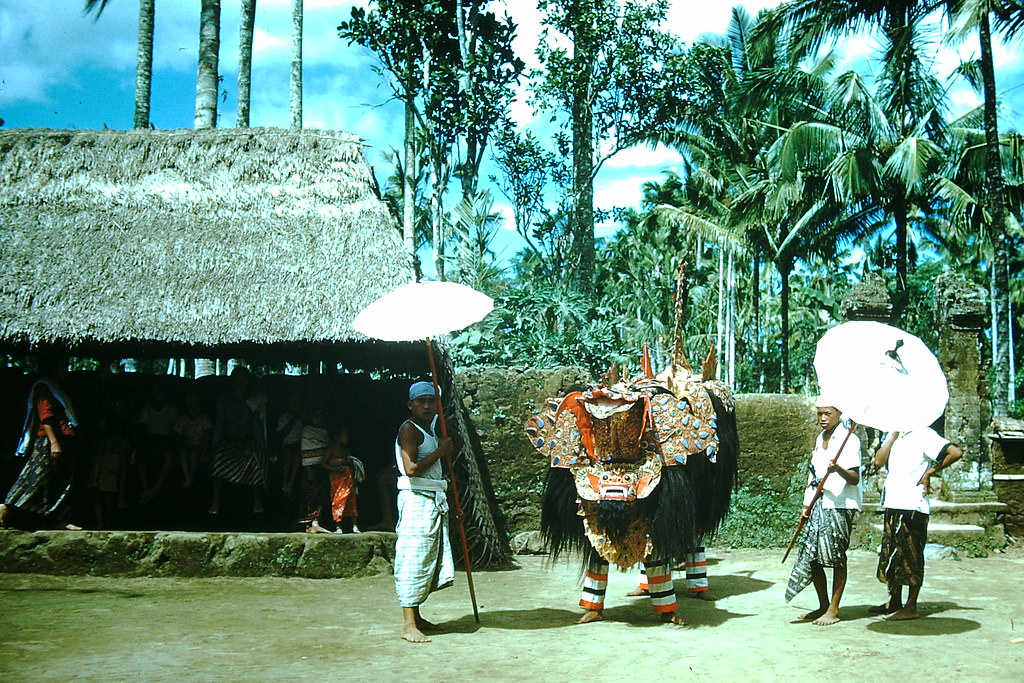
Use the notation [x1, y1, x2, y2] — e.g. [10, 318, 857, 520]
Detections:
[525, 377, 733, 566]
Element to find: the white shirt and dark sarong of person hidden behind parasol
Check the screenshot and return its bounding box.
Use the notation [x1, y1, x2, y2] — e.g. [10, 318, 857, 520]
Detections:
[878, 427, 949, 586]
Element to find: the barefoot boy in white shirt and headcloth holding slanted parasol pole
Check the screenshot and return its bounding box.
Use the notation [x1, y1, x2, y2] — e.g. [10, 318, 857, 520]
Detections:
[785, 397, 861, 626]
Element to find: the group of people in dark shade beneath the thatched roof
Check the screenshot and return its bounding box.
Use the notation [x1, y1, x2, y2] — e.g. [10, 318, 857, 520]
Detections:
[0, 365, 368, 532]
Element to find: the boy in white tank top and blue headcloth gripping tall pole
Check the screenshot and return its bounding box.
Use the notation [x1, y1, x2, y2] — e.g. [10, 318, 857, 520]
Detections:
[394, 382, 455, 643]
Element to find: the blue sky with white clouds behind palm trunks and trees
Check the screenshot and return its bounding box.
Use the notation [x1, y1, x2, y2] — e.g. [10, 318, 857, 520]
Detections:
[0, 0, 1024, 264]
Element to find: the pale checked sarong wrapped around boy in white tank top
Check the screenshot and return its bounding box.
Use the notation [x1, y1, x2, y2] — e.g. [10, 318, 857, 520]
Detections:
[394, 489, 455, 607]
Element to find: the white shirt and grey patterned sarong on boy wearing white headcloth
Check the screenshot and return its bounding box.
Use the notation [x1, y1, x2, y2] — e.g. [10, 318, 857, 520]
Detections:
[785, 424, 861, 602]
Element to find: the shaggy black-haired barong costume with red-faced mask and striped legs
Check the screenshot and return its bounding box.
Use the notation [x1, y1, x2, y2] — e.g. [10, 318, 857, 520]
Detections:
[525, 370, 739, 613]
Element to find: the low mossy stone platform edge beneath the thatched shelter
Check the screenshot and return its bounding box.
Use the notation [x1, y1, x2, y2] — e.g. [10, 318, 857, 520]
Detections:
[0, 529, 395, 579]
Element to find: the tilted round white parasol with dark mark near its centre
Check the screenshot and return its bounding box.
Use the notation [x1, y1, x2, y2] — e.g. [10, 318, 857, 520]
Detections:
[814, 321, 949, 431]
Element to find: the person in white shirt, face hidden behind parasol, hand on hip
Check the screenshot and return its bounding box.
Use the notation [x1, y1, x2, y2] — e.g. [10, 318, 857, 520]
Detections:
[868, 427, 964, 620]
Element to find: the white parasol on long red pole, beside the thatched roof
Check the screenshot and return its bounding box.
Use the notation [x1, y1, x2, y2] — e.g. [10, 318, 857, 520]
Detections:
[352, 281, 495, 624]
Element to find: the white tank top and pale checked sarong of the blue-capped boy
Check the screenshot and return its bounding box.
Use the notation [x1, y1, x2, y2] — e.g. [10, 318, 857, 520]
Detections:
[394, 420, 455, 607]
